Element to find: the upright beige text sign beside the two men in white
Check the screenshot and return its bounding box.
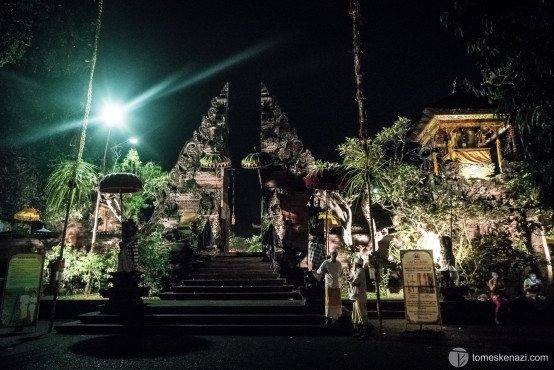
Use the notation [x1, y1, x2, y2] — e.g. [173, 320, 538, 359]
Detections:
[400, 249, 441, 324]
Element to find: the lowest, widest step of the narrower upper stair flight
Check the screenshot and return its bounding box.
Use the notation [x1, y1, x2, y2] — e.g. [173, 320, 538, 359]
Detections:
[155, 292, 302, 300]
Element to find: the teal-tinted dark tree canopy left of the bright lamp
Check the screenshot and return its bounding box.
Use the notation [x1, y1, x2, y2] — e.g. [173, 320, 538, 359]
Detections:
[0, 0, 97, 220]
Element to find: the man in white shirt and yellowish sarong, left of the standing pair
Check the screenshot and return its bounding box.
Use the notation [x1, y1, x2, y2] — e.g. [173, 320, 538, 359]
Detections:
[317, 250, 342, 326]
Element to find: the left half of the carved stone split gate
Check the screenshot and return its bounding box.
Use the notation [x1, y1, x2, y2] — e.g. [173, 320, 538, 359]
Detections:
[164, 83, 231, 252]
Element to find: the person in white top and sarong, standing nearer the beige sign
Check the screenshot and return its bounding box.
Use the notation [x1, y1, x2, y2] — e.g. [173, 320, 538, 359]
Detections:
[350, 257, 370, 339]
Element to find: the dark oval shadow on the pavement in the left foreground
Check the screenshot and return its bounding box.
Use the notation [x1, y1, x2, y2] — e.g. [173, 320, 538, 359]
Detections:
[69, 335, 211, 358]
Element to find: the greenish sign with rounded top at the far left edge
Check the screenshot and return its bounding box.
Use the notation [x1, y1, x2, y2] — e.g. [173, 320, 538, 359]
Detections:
[1, 253, 43, 326]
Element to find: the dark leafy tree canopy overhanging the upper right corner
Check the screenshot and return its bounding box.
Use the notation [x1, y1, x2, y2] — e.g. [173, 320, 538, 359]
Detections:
[441, 0, 554, 207]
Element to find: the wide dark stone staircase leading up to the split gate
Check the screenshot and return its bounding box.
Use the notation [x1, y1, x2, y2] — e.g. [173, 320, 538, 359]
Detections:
[55, 254, 404, 336]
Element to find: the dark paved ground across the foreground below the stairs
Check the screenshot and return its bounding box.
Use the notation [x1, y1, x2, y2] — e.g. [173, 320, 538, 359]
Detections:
[0, 319, 554, 370]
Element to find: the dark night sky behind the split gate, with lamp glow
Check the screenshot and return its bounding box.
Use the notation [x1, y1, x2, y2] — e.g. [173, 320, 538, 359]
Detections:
[87, 0, 478, 234]
